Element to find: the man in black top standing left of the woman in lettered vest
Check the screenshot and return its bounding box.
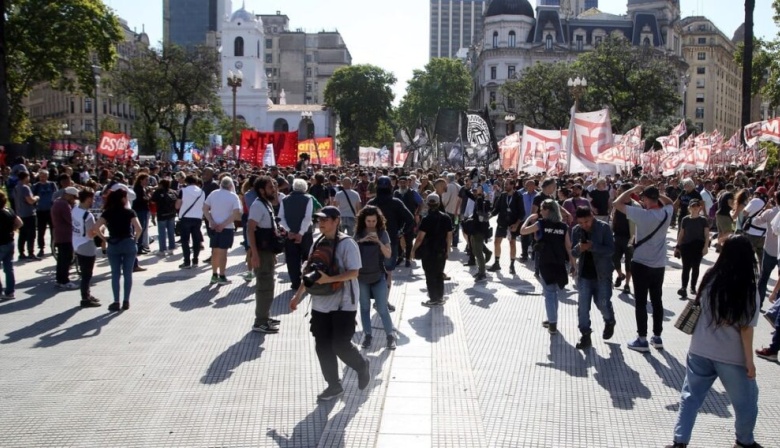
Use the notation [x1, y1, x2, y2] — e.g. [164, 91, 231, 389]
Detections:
[488, 179, 525, 275]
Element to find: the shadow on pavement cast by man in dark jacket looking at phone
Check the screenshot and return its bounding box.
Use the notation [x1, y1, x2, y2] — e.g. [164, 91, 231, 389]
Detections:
[586, 342, 652, 410]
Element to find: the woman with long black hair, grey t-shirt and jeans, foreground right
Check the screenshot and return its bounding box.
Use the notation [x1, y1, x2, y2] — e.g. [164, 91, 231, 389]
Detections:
[667, 235, 761, 448]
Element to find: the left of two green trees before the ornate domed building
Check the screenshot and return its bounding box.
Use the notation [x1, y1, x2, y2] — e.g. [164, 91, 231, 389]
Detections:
[500, 62, 583, 129]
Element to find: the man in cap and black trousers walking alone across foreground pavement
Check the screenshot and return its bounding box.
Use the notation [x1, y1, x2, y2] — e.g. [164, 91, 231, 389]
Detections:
[290, 206, 371, 401]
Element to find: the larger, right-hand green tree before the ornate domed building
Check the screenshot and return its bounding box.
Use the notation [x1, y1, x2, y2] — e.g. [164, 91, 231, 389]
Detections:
[573, 37, 682, 133]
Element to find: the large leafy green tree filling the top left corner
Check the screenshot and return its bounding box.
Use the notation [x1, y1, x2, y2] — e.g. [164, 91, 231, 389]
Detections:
[0, 0, 123, 142]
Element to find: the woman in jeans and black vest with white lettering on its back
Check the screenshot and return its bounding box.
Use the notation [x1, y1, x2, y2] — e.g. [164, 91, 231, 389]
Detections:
[520, 199, 575, 334]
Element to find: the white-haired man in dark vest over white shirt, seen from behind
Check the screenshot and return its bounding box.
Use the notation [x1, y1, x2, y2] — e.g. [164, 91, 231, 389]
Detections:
[279, 179, 314, 290]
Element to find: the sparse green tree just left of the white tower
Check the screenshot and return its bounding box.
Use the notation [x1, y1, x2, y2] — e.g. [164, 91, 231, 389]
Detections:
[113, 45, 221, 159]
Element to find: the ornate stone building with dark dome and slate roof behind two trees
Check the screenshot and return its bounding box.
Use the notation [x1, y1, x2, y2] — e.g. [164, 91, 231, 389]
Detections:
[470, 0, 687, 139]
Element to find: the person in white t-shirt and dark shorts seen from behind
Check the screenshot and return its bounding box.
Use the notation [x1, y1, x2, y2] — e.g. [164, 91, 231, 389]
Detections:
[203, 176, 241, 285]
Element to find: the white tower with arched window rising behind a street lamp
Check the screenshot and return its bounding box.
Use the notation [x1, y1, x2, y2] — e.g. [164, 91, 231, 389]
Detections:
[219, 2, 268, 130]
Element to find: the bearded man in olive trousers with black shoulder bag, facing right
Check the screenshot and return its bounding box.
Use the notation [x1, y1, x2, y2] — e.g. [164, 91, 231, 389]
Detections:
[247, 176, 279, 334]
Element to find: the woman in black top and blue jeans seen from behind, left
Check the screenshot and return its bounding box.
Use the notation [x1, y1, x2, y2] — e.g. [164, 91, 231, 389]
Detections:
[92, 188, 141, 311]
